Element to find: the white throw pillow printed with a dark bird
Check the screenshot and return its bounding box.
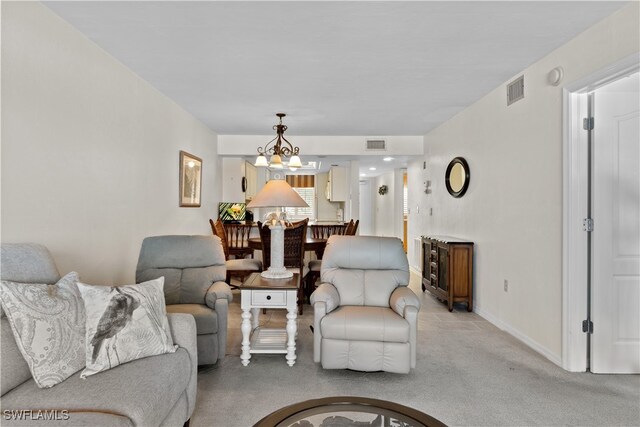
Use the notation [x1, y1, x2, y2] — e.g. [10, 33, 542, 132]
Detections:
[78, 277, 177, 378]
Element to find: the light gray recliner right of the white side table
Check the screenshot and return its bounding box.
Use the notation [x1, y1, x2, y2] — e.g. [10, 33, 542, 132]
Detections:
[311, 235, 420, 373]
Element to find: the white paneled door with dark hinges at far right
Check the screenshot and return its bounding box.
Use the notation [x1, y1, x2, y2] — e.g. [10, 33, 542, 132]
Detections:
[591, 73, 640, 373]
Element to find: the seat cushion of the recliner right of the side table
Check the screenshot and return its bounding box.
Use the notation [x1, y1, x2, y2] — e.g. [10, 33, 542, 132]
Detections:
[320, 305, 409, 342]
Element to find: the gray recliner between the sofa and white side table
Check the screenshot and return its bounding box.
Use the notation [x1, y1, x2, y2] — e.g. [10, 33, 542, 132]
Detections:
[136, 236, 233, 365]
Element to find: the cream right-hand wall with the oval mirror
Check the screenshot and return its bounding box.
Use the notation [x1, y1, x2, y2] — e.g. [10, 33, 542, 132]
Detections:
[409, 3, 640, 364]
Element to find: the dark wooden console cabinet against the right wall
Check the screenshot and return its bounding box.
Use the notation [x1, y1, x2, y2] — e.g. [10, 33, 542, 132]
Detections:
[422, 236, 473, 311]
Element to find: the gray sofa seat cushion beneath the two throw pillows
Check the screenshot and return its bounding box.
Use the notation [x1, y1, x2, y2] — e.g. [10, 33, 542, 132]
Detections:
[1, 348, 192, 426]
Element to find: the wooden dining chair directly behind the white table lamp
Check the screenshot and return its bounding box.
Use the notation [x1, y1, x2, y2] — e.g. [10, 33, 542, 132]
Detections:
[258, 219, 309, 314]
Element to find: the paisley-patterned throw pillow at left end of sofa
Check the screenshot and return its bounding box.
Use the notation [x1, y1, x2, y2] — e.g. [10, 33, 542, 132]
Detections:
[0, 272, 85, 388]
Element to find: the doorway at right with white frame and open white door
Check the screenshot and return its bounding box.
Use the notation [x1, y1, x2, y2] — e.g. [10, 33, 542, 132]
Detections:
[562, 55, 640, 373]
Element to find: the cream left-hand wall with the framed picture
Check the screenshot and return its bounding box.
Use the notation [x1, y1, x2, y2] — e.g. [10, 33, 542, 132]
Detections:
[1, 2, 221, 284]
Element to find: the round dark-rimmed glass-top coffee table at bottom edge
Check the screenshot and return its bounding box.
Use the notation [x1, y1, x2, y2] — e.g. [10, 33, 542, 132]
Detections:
[254, 396, 445, 427]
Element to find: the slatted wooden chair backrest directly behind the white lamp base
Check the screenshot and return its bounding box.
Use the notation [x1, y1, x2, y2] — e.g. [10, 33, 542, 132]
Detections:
[258, 219, 309, 270]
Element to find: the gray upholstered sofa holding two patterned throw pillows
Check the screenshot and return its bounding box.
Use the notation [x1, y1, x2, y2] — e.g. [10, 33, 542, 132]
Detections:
[0, 244, 197, 427]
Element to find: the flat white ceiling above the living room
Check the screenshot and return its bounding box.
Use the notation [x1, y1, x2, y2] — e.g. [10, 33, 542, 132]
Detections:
[46, 1, 624, 136]
